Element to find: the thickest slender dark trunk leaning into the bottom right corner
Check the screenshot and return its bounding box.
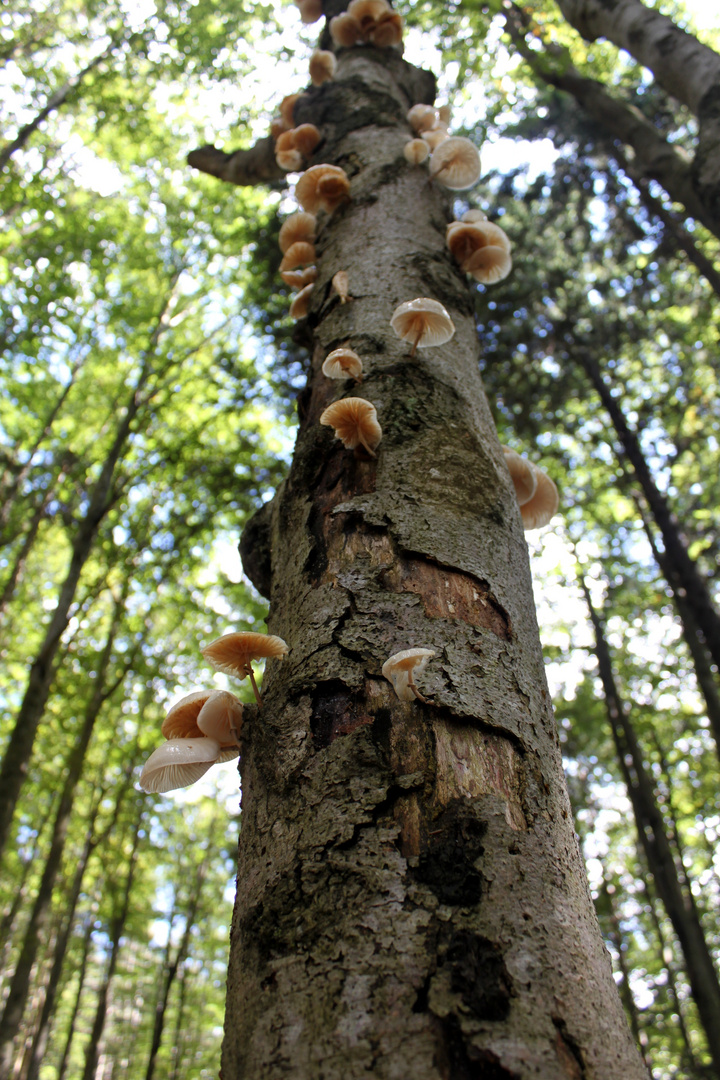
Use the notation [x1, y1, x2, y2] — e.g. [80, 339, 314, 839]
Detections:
[580, 577, 720, 1075]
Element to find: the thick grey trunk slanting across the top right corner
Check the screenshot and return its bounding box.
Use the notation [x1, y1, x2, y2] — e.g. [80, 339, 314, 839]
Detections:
[558, 0, 720, 225]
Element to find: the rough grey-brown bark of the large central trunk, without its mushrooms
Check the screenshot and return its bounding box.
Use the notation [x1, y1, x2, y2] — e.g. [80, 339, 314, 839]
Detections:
[222, 46, 647, 1080]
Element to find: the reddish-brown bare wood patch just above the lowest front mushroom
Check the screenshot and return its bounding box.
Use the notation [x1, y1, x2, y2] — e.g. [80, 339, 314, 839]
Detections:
[382, 556, 512, 642]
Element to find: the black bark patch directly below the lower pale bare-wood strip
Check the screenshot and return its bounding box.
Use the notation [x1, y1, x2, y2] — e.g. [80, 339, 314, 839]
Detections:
[415, 804, 486, 907]
